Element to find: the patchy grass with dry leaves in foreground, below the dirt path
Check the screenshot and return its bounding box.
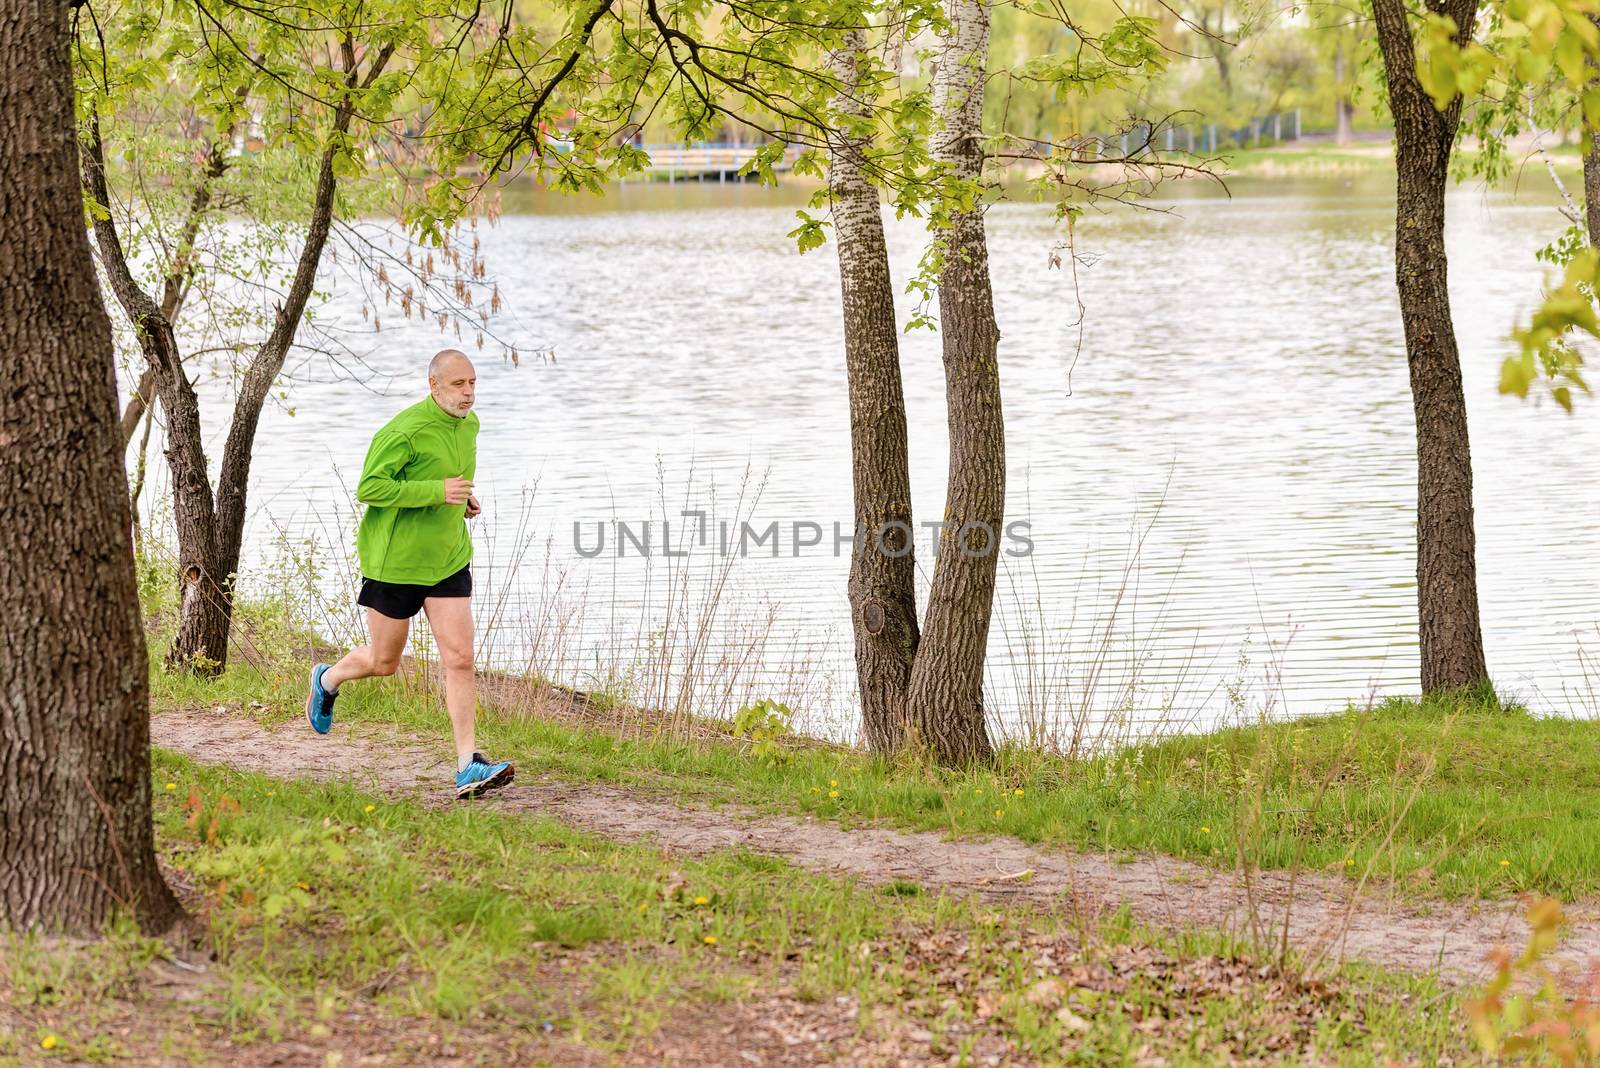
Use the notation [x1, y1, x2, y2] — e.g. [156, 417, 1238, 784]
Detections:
[0, 751, 1466, 1065]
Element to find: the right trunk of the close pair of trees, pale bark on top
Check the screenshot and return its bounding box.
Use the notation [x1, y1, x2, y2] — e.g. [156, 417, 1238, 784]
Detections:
[907, 0, 1005, 764]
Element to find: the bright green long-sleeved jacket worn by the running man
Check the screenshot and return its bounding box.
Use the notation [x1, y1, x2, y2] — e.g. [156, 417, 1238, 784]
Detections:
[355, 397, 478, 585]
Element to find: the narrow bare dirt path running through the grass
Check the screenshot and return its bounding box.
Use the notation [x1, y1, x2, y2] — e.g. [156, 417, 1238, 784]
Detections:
[150, 711, 1600, 982]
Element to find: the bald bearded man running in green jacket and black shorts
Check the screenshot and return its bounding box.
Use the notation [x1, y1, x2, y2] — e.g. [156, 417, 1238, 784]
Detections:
[306, 349, 515, 798]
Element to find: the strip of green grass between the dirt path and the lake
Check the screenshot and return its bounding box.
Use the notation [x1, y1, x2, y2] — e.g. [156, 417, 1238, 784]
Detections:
[154, 639, 1600, 900]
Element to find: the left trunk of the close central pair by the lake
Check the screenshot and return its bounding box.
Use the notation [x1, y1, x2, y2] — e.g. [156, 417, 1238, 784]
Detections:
[829, 30, 918, 753]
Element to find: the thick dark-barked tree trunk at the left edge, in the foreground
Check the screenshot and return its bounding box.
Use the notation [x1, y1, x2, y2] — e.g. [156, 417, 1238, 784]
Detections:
[0, 2, 181, 932]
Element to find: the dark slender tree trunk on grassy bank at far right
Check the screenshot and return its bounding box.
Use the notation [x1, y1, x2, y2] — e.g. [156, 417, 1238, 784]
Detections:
[1374, 0, 1488, 692]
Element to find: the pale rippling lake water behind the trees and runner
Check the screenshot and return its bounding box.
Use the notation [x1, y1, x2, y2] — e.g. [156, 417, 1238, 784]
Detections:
[152, 176, 1600, 737]
